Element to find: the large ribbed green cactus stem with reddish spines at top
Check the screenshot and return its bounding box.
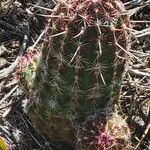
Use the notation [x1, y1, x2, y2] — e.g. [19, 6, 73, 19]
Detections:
[28, 0, 130, 141]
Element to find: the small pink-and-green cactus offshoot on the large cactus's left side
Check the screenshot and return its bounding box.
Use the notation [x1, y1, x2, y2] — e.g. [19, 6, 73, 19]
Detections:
[14, 51, 40, 93]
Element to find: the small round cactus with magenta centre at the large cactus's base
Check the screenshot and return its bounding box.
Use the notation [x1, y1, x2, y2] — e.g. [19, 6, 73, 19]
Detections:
[76, 109, 131, 150]
